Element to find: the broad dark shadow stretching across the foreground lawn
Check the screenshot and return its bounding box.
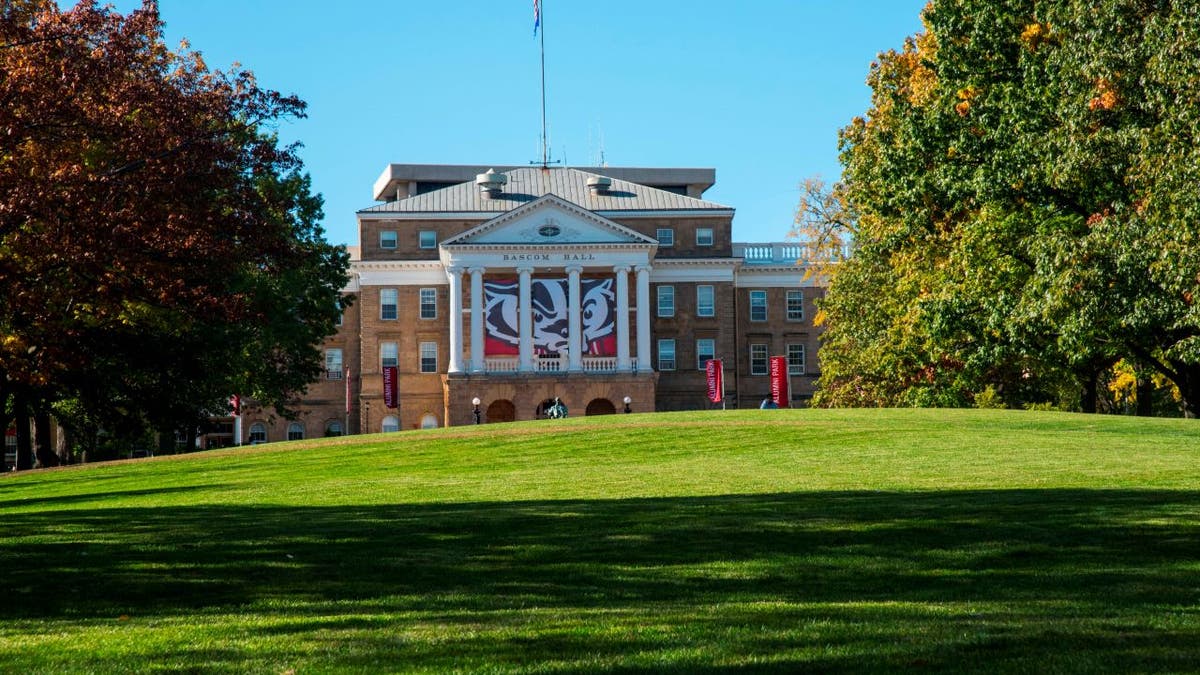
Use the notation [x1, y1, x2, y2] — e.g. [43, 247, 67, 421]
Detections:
[0, 490, 1200, 673]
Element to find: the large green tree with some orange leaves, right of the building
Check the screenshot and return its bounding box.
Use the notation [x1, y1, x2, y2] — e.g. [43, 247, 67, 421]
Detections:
[822, 0, 1200, 414]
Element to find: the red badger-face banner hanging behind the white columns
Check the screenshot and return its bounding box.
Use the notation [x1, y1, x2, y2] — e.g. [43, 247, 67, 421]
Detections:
[484, 279, 617, 357]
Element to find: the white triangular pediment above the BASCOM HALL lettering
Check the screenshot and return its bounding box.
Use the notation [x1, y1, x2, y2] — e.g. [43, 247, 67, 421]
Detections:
[442, 195, 658, 246]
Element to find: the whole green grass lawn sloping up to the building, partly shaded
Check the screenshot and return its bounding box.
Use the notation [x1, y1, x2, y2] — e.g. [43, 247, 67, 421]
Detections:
[0, 410, 1200, 674]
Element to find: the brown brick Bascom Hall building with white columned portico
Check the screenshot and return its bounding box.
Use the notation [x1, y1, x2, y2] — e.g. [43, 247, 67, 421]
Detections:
[239, 165, 823, 442]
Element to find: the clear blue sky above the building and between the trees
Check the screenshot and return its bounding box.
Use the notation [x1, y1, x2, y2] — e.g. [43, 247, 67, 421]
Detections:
[100, 0, 926, 245]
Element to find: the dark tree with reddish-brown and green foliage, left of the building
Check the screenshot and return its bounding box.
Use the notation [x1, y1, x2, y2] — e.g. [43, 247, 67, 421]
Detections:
[0, 0, 348, 460]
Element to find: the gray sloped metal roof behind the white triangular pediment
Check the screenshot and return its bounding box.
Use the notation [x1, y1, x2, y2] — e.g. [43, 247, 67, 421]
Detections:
[359, 167, 733, 214]
